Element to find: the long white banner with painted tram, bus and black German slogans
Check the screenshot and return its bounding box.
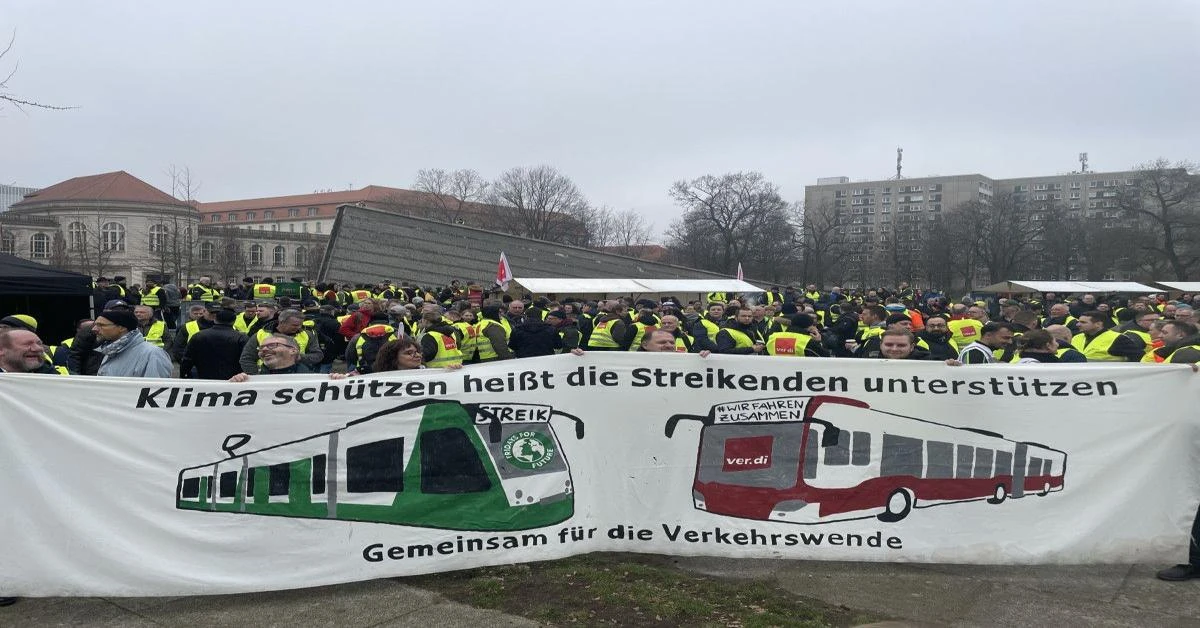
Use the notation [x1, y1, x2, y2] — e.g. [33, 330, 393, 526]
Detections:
[0, 353, 1200, 596]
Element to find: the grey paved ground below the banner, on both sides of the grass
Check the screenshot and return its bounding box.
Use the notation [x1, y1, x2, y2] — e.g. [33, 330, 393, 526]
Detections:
[7, 558, 1200, 628]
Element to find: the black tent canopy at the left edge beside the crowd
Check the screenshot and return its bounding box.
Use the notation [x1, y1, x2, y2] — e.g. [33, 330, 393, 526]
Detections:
[0, 255, 91, 345]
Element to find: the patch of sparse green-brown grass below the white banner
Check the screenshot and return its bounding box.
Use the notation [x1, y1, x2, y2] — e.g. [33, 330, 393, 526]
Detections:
[401, 554, 880, 628]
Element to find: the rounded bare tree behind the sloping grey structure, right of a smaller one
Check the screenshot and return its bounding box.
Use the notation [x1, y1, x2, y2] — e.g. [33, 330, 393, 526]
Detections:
[491, 166, 593, 245]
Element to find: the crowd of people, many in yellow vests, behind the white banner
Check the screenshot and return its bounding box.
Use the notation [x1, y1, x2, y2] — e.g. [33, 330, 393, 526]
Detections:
[0, 277, 1200, 604]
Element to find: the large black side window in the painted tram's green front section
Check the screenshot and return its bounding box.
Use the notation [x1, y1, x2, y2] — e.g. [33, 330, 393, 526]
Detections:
[421, 427, 492, 495]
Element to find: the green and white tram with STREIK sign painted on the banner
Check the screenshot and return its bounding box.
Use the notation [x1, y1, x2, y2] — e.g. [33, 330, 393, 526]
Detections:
[175, 400, 583, 531]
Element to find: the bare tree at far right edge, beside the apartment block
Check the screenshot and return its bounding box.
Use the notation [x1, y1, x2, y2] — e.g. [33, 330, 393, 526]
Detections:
[1102, 159, 1200, 281]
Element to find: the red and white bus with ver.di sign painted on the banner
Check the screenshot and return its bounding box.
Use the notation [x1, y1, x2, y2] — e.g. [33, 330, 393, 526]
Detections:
[666, 395, 1067, 524]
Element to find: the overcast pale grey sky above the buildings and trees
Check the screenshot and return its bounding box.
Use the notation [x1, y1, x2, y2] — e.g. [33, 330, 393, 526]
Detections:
[0, 0, 1200, 231]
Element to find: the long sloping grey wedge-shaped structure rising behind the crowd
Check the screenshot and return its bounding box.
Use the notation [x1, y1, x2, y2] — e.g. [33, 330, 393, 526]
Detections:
[320, 205, 730, 285]
